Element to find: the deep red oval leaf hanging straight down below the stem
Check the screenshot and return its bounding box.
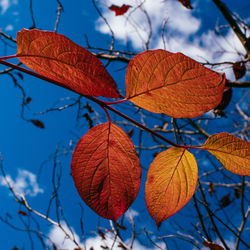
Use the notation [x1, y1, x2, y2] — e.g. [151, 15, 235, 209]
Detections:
[71, 122, 141, 220]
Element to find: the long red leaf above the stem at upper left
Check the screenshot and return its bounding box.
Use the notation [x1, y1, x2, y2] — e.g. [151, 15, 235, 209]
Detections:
[17, 29, 120, 98]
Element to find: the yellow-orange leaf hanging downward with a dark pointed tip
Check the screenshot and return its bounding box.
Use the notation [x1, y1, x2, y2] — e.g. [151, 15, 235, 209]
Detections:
[145, 148, 198, 227]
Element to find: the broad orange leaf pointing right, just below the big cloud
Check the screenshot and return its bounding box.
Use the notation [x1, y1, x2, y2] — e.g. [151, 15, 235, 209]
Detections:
[126, 50, 225, 118]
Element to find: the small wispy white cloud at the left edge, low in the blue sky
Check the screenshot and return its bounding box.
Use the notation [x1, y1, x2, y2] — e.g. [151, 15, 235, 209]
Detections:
[0, 169, 43, 196]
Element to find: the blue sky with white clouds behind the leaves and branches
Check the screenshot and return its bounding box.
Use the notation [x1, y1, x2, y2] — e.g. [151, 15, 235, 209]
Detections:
[0, 0, 249, 249]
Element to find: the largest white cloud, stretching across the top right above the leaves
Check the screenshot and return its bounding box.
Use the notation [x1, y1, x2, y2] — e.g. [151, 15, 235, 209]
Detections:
[96, 0, 249, 79]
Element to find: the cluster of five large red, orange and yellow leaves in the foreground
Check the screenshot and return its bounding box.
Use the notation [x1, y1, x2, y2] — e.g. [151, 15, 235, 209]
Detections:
[0, 29, 250, 226]
